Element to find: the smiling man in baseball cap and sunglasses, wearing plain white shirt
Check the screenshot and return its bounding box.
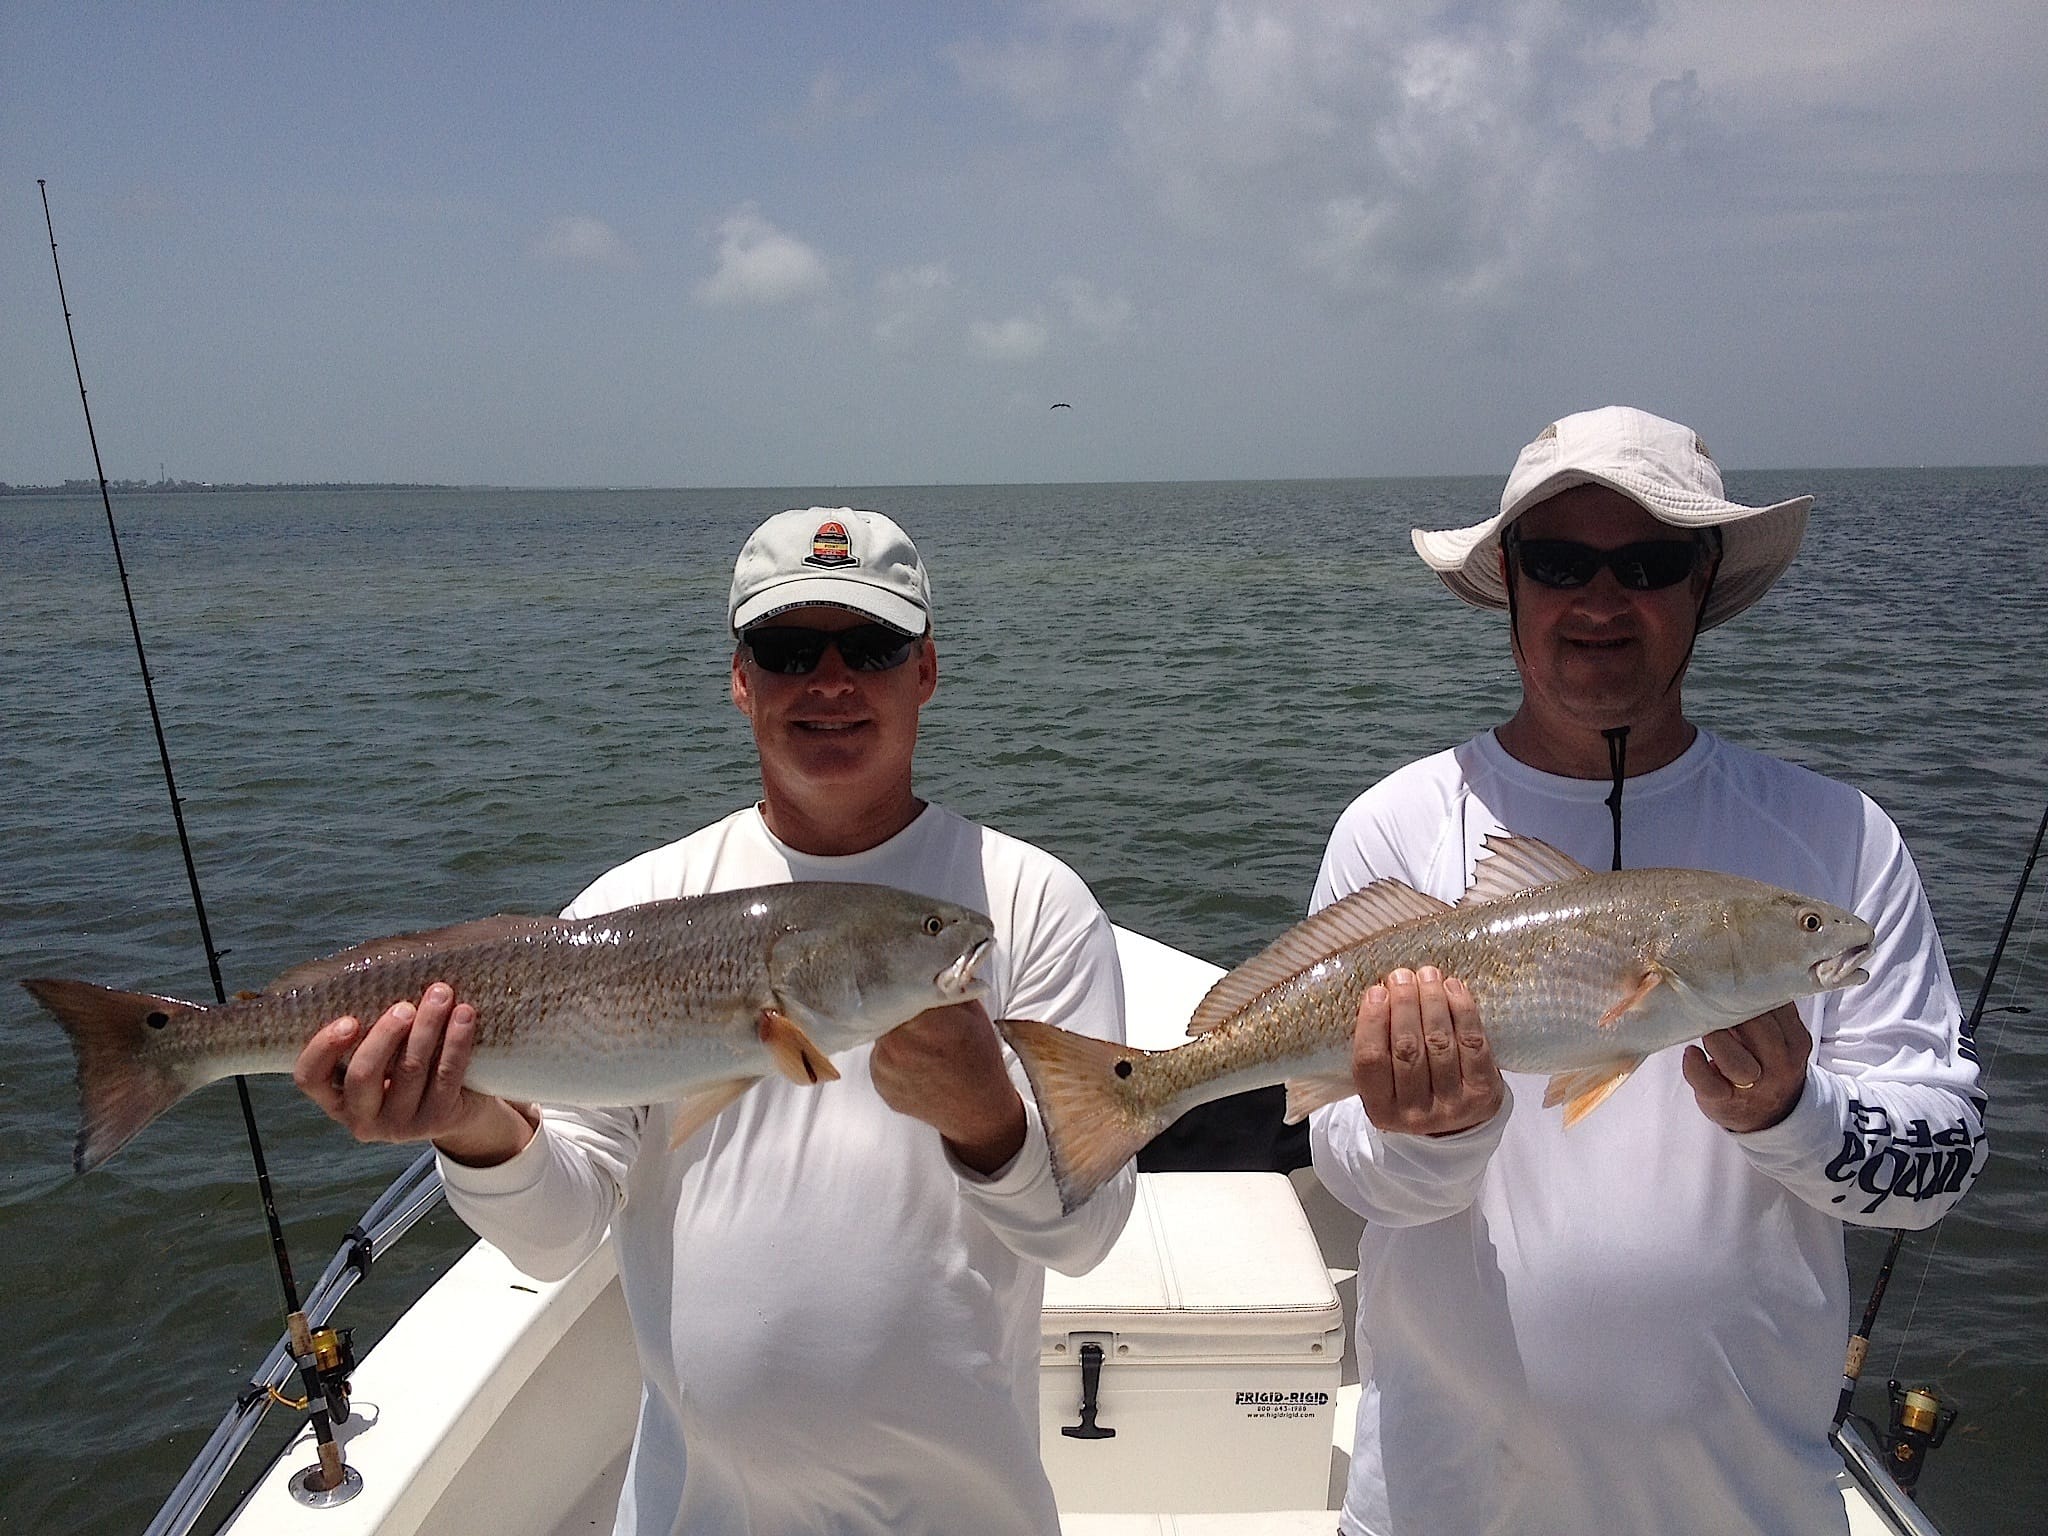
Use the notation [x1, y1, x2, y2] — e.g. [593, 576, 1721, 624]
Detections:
[297, 508, 1135, 1536]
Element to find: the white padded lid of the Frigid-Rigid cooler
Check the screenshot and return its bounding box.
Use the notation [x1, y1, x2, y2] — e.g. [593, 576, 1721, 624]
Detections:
[1044, 1174, 1343, 1333]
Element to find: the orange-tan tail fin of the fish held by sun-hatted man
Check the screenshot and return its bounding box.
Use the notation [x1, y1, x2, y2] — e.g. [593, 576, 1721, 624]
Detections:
[995, 1018, 1174, 1212]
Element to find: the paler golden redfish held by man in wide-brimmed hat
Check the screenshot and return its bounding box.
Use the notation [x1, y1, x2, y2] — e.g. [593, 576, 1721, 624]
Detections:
[997, 838, 1874, 1210]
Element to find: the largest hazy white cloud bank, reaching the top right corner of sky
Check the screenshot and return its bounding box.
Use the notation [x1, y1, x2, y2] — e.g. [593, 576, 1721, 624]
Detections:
[948, 0, 2042, 325]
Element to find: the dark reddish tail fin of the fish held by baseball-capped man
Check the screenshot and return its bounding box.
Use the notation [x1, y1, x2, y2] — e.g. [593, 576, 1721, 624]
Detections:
[20, 977, 201, 1174]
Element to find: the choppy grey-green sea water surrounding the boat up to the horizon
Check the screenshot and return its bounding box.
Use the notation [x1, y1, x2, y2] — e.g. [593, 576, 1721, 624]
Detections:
[0, 469, 2048, 1536]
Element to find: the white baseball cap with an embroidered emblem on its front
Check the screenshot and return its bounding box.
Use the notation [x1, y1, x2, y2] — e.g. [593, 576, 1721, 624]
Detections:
[725, 506, 932, 635]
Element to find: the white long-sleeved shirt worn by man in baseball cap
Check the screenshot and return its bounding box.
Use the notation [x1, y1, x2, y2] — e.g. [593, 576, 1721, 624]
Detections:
[440, 805, 1137, 1536]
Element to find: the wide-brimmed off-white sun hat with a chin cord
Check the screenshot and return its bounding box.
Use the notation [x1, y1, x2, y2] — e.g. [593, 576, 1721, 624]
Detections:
[1409, 406, 1812, 629]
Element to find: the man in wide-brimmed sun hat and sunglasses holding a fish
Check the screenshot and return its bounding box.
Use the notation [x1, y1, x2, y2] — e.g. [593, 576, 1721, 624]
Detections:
[1311, 408, 1985, 1536]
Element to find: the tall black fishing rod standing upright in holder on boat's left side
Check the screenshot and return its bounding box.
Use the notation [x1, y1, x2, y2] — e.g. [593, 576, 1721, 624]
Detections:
[35, 176, 362, 1503]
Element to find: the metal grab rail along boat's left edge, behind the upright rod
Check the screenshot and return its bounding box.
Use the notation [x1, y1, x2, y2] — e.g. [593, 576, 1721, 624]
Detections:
[143, 1151, 440, 1536]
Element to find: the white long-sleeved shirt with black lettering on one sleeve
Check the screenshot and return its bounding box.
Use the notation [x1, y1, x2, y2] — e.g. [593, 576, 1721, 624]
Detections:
[1311, 731, 1985, 1536]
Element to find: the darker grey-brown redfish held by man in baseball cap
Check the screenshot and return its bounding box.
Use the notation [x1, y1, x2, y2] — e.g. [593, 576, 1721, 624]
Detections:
[23, 883, 993, 1174]
